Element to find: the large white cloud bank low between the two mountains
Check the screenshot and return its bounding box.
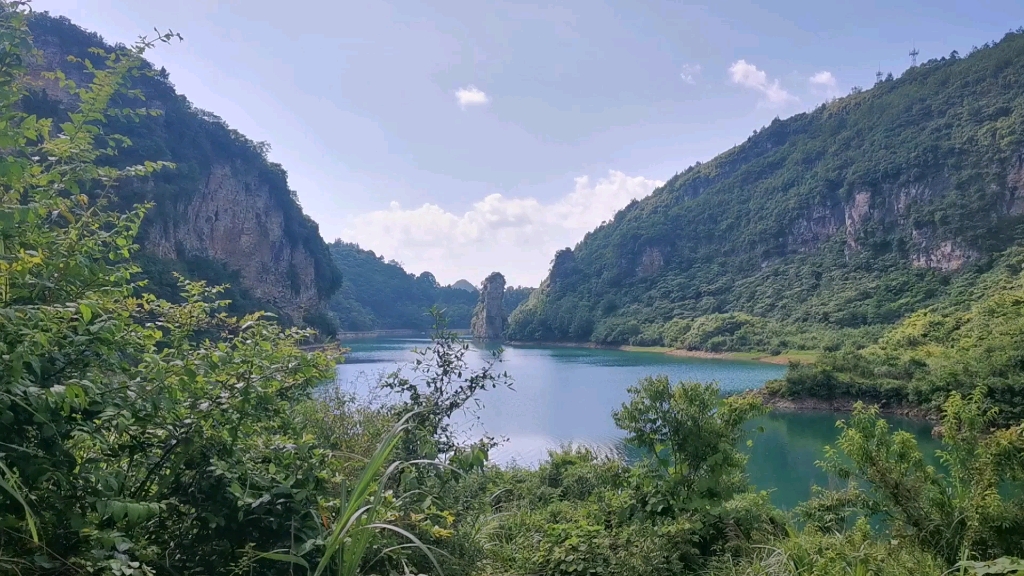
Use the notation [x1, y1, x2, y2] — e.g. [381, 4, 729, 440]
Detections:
[341, 170, 665, 286]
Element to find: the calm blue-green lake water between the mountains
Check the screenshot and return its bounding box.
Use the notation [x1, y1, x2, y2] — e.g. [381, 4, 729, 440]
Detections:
[337, 338, 938, 508]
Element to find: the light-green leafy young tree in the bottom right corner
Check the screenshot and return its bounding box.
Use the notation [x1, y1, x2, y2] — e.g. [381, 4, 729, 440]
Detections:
[800, 387, 1024, 564]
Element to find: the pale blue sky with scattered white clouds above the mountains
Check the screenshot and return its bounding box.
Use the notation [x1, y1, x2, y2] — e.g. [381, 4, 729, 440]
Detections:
[33, 0, 1024, 285]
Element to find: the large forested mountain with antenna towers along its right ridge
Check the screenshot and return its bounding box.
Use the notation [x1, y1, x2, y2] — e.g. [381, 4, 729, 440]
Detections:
[509, 31, 1024, 349]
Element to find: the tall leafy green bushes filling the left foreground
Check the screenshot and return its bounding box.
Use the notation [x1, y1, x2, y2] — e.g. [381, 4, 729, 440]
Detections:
[0, 7, 456, 576]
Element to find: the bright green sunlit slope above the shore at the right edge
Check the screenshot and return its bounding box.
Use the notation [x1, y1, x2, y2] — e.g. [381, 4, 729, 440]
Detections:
[768, 248, 1024, 423]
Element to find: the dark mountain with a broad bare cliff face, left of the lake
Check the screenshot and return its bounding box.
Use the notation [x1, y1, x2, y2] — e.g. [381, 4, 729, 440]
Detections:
[22, 12, 341, 323]
